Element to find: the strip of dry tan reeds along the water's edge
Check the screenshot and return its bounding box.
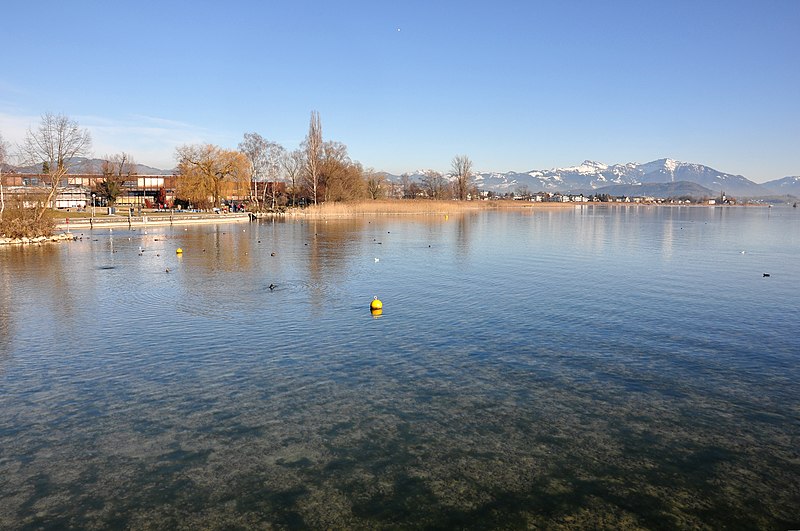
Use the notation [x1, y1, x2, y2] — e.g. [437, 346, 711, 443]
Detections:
[288, 199, 574, 218]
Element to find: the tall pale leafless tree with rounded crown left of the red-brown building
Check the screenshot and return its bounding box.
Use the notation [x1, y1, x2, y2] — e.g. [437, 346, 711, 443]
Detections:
[19, 113, 92, 221]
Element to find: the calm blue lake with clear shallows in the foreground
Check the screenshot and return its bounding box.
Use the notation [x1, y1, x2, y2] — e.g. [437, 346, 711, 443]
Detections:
[0, 206, 800, 529]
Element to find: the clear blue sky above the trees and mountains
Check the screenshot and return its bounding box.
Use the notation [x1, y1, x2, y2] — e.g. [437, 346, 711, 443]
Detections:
[0, 0, 800, 182]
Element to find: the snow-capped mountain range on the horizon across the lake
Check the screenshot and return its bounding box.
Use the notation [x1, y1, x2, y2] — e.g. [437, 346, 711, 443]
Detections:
[474, 159, 770, 197]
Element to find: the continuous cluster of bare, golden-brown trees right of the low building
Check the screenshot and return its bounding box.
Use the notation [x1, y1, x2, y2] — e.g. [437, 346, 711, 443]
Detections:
[176, 111, 477, 209]
